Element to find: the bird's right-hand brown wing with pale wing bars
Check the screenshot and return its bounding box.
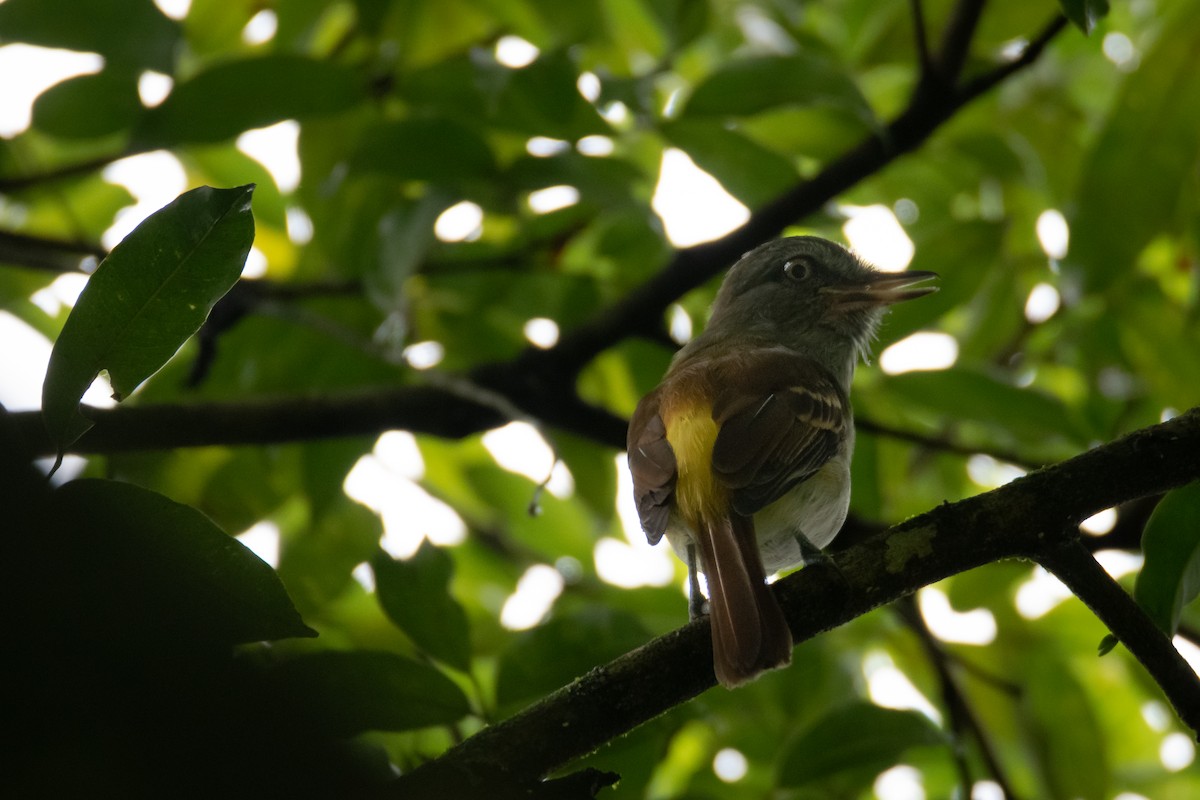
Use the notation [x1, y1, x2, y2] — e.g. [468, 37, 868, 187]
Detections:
[713, 349, 850, 515]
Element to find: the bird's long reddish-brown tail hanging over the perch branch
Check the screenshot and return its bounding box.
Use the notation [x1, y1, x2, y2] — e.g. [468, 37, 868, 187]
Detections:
[696, 512, 792, 688]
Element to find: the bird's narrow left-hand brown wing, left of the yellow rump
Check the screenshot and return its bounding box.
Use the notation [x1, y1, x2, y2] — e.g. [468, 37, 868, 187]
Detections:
[626, 390, 678, 545]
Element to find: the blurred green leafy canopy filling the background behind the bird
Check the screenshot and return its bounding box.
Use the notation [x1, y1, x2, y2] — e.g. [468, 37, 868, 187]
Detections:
[0, 0, 1200, 799]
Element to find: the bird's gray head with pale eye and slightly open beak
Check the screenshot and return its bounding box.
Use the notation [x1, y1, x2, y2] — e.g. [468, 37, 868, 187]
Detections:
[706, 236, 937, 360]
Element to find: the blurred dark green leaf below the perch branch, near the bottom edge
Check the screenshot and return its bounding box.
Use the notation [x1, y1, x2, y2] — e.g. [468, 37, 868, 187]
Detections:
[779, 703, 946, 787]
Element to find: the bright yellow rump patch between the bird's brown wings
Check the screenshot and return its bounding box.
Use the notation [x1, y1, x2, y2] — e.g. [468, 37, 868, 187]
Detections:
[664, 402, 728, 525]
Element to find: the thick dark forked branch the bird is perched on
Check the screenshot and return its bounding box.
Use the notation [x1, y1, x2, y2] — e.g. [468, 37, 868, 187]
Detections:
[389, 408, 1200, 798]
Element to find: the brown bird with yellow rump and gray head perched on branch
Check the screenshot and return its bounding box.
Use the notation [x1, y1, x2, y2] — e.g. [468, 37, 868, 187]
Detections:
[626, 236, 937, 688]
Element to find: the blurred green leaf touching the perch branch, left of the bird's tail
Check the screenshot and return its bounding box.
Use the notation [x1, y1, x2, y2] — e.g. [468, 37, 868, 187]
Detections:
[496, 608, 650, 705]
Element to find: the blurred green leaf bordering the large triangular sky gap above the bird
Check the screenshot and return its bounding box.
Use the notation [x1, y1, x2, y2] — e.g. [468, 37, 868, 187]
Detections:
[662, 119, 797, 206]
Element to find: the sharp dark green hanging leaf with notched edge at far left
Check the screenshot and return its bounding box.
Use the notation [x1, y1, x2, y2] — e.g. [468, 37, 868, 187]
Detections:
[42, 186, 254, 451]
